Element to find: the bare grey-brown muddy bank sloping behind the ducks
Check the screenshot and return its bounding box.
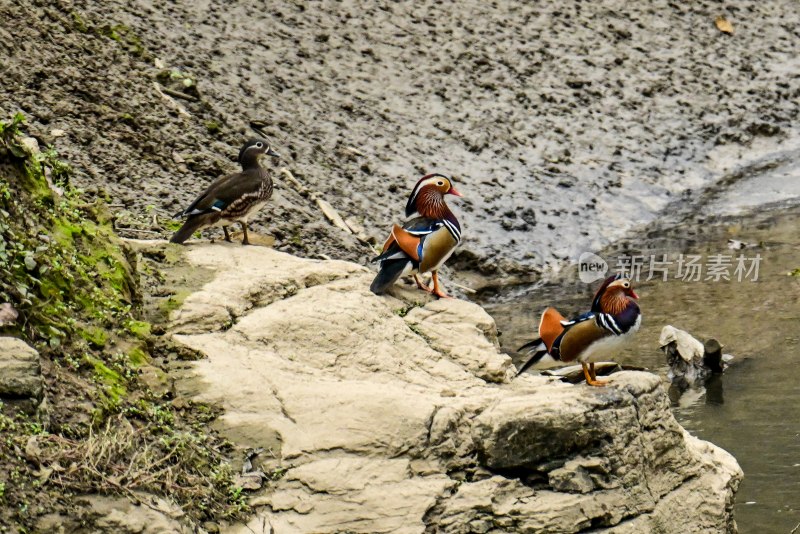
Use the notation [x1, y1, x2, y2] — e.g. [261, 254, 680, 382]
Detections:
[0, 0, 800, 283]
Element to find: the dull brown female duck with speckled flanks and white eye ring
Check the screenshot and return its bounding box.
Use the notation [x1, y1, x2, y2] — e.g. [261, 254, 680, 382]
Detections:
[170, 138, 279, 245]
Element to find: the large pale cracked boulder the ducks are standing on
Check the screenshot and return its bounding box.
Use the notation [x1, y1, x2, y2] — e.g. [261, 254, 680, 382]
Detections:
[172, 244, 742, 533]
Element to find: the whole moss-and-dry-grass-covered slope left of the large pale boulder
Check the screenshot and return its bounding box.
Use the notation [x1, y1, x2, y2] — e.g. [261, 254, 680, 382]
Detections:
[0, 114, 246, 532]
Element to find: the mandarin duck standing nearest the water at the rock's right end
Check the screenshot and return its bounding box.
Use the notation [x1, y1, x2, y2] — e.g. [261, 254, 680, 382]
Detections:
[517, 275, 642, 386]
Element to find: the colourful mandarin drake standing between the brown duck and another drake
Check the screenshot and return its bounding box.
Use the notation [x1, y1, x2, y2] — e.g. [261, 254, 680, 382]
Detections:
[369, 174, 461, 298]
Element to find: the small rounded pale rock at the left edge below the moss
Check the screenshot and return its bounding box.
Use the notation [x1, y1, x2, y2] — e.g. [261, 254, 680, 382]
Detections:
[0, 337, 44, 401]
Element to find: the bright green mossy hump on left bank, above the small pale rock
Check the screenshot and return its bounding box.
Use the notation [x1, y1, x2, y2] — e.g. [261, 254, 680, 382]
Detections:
[0, 116, 135, 348]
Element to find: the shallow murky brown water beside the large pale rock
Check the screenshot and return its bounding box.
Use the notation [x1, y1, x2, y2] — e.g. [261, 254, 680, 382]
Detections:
[481, 206, 800, 533]
